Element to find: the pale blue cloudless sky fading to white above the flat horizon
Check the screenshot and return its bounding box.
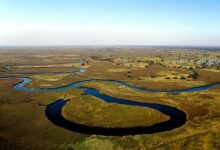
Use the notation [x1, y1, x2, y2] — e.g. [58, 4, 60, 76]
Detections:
[0, 0, 220, 46]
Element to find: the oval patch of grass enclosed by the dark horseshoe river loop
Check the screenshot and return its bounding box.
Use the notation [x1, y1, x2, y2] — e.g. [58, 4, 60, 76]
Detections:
[62, 96, 169, 128]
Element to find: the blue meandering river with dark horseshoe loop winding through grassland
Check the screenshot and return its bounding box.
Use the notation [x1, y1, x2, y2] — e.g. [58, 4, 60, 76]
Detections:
[1, 62, 220, 136]
